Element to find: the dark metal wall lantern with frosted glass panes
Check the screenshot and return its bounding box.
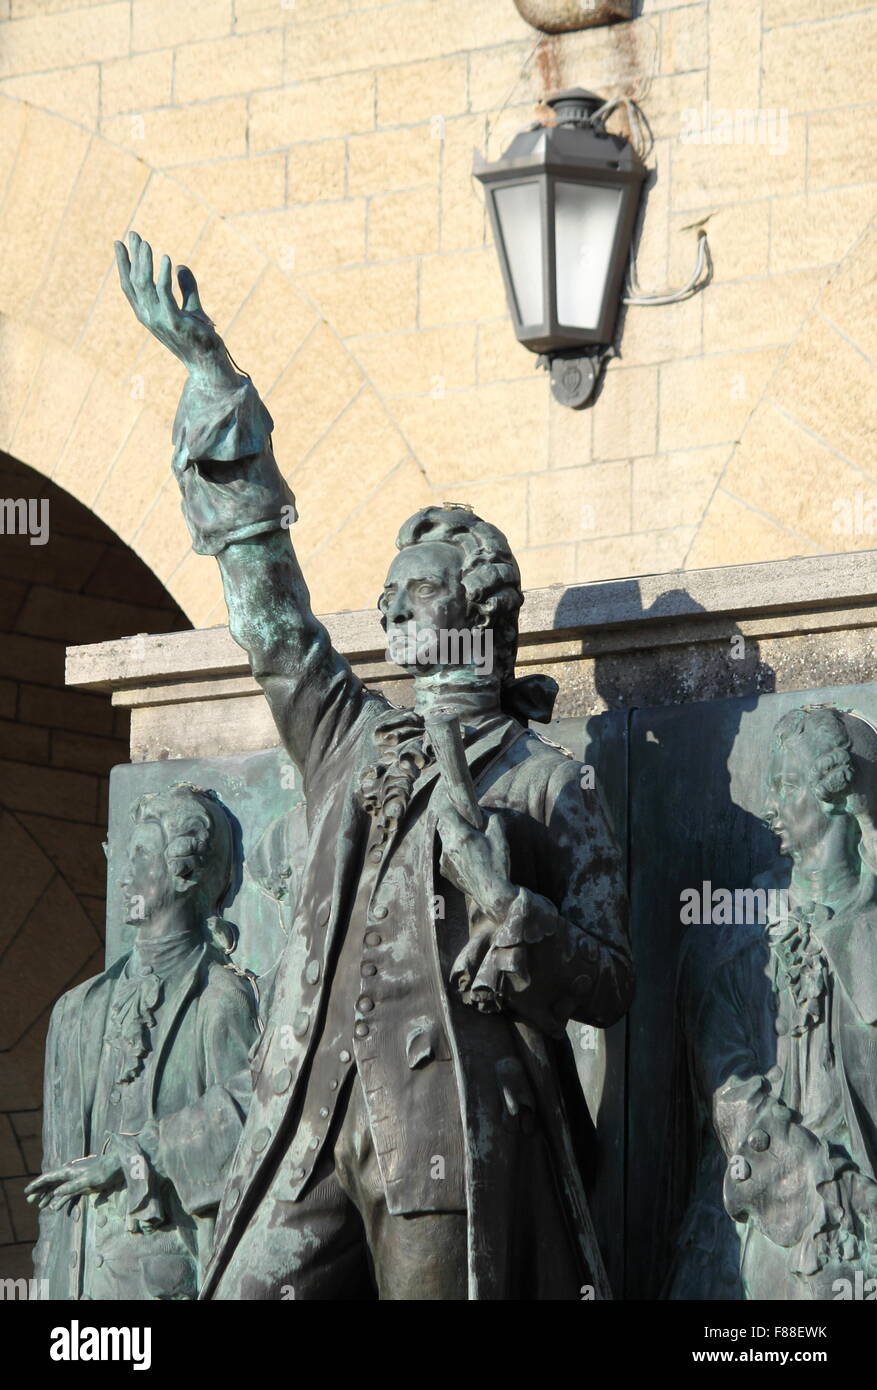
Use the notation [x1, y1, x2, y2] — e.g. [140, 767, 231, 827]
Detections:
[473, 88, 648, 406]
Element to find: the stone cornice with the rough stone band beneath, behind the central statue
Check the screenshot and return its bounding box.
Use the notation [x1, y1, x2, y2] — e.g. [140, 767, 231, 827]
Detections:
[67, 550, 877, 762]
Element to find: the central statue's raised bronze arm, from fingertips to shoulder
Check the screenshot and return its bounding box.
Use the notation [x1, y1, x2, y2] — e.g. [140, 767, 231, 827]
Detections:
[115, 232, 366, 781]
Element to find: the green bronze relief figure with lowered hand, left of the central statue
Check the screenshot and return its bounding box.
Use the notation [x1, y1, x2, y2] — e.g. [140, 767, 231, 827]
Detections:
[26, 784, 259, 1300]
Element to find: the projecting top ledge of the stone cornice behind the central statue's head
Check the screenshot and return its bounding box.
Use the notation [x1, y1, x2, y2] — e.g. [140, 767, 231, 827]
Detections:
[67, 550, 877, 691]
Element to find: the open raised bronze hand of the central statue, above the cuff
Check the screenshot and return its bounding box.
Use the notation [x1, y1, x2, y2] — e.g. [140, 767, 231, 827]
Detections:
[115, 232, 238, 385]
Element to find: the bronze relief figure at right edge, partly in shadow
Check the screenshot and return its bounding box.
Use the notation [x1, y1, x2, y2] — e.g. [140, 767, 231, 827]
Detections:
[669, 706, 877, 1300]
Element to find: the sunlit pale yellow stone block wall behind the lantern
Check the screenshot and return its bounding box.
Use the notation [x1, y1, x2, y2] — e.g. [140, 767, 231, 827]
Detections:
[0, 0, 877, 626]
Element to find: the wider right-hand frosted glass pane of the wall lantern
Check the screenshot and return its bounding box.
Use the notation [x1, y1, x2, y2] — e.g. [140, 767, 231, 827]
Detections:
[555, 179, 621, 328]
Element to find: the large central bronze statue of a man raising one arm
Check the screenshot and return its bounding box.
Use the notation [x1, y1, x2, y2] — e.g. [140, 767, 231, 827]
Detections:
[117, 234, 632, 1300]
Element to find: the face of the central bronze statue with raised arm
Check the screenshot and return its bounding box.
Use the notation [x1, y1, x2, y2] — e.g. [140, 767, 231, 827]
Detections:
[378, 541, 470, 674]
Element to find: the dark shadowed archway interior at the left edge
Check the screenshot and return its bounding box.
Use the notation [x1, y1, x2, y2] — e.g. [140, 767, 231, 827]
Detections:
[0, 455, 190, 1277]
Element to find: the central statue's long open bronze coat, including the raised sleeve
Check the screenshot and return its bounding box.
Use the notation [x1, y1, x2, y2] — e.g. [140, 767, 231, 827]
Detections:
[174, 381, 632, 1298]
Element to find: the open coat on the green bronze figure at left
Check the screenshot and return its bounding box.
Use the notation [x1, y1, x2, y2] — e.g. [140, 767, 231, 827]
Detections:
[33, 945, 259, 1300]
